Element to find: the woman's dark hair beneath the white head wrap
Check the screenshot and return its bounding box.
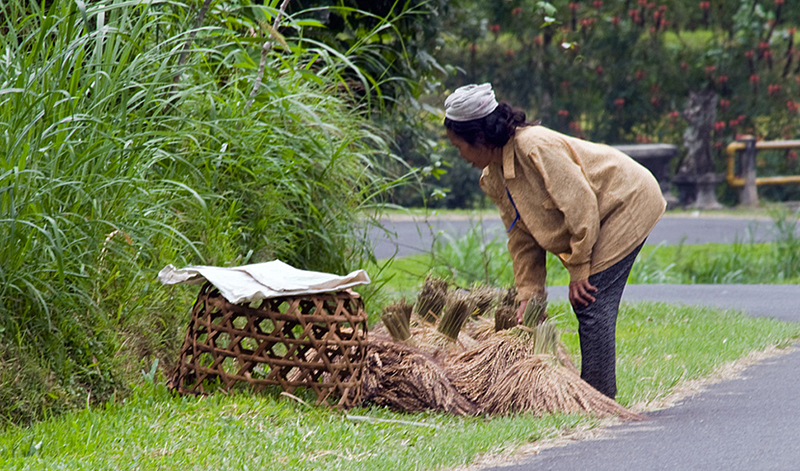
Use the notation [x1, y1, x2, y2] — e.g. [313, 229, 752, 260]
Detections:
[444, 102, 538, 147]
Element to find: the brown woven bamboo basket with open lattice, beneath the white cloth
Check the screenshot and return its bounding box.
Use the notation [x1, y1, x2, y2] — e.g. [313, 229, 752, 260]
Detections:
[170, 283, 367, 408]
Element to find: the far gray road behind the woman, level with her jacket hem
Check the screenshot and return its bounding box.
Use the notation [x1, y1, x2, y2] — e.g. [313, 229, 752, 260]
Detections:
[372, 215, 800, 258]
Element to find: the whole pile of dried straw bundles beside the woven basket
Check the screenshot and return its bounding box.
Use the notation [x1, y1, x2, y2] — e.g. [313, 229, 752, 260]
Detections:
[362, 277, 638, 420]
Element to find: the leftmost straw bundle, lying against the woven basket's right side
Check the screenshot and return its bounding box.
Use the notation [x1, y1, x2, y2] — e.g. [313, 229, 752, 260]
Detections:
[362, 341, 478, 415]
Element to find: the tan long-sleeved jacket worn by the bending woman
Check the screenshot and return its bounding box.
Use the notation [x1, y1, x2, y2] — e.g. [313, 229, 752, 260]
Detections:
[480, 126, 666, 300]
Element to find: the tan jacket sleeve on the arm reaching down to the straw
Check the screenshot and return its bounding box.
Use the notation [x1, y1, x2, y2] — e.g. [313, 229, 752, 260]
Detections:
[481, 171, 547, 301]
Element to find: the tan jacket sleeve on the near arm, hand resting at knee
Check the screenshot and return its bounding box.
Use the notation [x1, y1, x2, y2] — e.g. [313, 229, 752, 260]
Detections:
[530, 144, 600, 281]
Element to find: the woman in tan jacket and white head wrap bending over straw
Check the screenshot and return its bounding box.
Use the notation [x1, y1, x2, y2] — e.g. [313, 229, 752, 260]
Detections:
[444, 83, 666, 399]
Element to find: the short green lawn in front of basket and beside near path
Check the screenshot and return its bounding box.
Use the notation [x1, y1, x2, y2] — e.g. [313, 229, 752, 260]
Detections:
[0, 303, 800, 470]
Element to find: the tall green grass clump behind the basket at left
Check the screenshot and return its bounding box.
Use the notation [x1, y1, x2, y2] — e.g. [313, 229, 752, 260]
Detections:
[0, 0, 406, 422]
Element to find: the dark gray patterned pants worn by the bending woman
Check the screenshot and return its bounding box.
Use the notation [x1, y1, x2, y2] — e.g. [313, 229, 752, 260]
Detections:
[572, 242, 644, 399]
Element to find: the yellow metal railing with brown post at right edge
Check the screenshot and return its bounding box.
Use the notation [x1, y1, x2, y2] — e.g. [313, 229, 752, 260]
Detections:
[726, 136, 800, 206]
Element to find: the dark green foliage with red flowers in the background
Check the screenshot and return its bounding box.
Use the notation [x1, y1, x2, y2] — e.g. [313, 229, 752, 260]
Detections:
[441, 0, 800, 148]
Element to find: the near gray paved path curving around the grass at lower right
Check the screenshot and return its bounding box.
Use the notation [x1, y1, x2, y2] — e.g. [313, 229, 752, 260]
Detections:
[484, 285, 800, 471]
